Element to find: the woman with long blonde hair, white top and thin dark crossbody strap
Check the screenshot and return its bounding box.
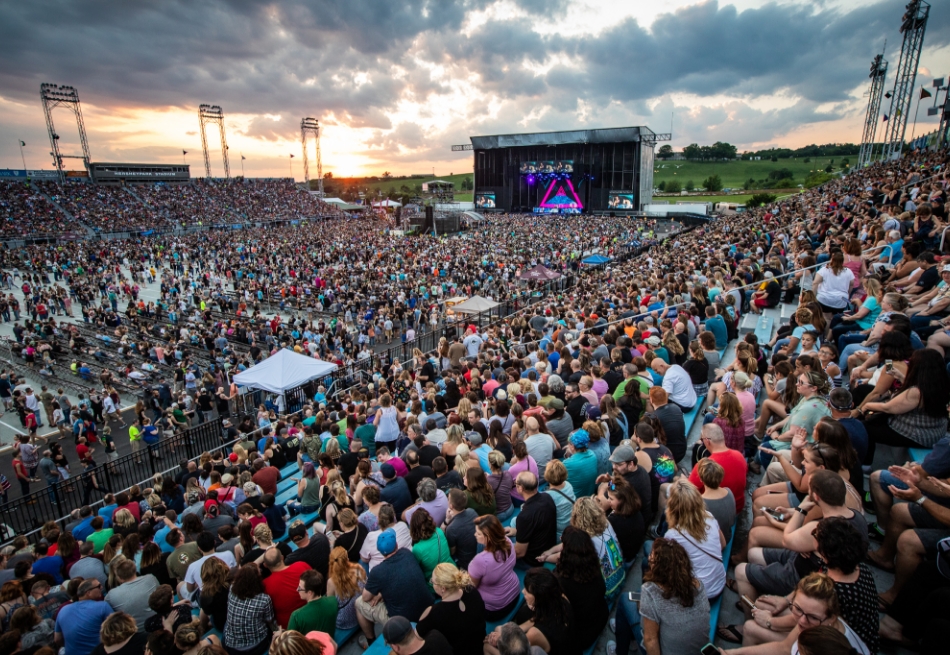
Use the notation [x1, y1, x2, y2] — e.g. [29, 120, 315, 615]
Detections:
[664, 478, 728, 599]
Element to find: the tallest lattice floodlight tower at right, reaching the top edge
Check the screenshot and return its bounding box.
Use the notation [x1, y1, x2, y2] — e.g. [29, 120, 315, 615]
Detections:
[881, 0, 930, 161]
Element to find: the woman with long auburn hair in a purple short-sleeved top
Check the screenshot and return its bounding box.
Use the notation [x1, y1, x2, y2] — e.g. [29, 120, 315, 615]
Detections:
[468, 515, 521, 621]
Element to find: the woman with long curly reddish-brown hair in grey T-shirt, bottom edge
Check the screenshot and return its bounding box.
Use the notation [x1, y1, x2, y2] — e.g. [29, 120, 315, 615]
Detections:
[607, 538, 722, 655]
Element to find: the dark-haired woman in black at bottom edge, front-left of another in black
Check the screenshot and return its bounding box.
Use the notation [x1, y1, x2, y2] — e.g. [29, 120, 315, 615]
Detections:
[485, 568, 574, 655]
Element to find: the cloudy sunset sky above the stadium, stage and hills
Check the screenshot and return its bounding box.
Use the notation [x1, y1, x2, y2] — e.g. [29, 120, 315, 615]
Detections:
[0, 0, 950, 180]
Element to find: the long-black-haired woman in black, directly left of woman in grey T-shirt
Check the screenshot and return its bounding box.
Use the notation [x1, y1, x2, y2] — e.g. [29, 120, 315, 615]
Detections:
[554, 515, 608, 652]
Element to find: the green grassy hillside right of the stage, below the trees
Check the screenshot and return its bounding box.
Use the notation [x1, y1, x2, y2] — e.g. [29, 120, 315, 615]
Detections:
[653, 155, 858, 189]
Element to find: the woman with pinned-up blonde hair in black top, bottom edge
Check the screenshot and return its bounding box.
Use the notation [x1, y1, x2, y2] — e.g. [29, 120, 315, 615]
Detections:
[416, 562, 485, 655]
